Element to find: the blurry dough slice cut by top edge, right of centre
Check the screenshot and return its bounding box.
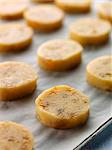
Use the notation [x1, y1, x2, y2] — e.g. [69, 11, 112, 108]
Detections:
[56, 0, 92, 13]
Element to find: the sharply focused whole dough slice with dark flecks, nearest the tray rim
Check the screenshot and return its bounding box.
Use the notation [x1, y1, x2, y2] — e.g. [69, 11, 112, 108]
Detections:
[36, 85, 89, 129]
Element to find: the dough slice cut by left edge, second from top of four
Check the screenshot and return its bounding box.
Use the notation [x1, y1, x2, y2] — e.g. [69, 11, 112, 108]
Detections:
[0, 23, 33, 52]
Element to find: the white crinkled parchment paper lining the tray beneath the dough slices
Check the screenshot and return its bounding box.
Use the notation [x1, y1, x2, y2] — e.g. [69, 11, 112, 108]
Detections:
[0, 0, 112, 150]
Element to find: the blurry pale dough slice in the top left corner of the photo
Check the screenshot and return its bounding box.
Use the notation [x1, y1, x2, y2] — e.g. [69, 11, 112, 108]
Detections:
[0, 0, 28, 19]
